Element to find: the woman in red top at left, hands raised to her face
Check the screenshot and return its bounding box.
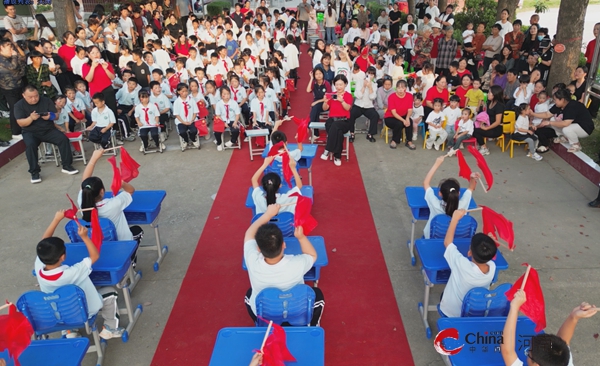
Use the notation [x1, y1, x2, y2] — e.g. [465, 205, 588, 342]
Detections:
[82, 46, 117, 116]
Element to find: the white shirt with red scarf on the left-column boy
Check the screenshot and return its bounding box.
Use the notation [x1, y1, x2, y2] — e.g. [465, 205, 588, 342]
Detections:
[34, 258, 103, 318]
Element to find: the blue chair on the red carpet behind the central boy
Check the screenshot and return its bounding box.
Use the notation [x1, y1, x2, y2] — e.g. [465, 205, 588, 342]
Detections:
[256, 284, 315, 327]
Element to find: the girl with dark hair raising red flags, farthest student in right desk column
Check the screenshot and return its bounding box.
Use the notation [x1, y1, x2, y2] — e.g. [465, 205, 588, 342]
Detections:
[423, 156, 479, 239]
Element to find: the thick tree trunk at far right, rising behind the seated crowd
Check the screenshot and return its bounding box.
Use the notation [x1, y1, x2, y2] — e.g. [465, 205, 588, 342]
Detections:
[547, 0, 589, 90]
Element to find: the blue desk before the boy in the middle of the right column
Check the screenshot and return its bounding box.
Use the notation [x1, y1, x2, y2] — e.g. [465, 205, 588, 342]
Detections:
[415, 239, 508, 338]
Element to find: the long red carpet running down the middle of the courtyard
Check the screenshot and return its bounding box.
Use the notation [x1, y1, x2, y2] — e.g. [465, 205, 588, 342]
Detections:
[152, 50, 414, 366]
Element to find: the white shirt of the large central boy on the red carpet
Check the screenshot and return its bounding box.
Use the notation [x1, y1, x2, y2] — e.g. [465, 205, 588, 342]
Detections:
[244, 240, 314, 314]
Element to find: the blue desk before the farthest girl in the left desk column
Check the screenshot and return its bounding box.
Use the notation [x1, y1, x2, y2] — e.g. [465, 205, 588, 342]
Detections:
[104, 190, 169, 271]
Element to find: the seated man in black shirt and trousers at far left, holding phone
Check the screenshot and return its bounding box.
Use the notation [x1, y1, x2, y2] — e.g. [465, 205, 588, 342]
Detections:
[14, 85, 79, 183]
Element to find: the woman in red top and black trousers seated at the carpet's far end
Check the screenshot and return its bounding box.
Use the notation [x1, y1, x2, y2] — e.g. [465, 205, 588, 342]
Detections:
[321, 75, 353, 166]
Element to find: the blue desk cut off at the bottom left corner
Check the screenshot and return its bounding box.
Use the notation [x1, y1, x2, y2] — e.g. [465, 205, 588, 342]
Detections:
[0, 338, 91, 366]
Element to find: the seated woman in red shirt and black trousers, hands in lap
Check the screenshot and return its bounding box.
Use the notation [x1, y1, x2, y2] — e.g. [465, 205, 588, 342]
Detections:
[384, 80, 416, 150]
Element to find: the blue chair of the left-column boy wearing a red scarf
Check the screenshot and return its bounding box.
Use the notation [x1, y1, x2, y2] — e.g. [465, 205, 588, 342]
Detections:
[17, 285, 106, 365]
